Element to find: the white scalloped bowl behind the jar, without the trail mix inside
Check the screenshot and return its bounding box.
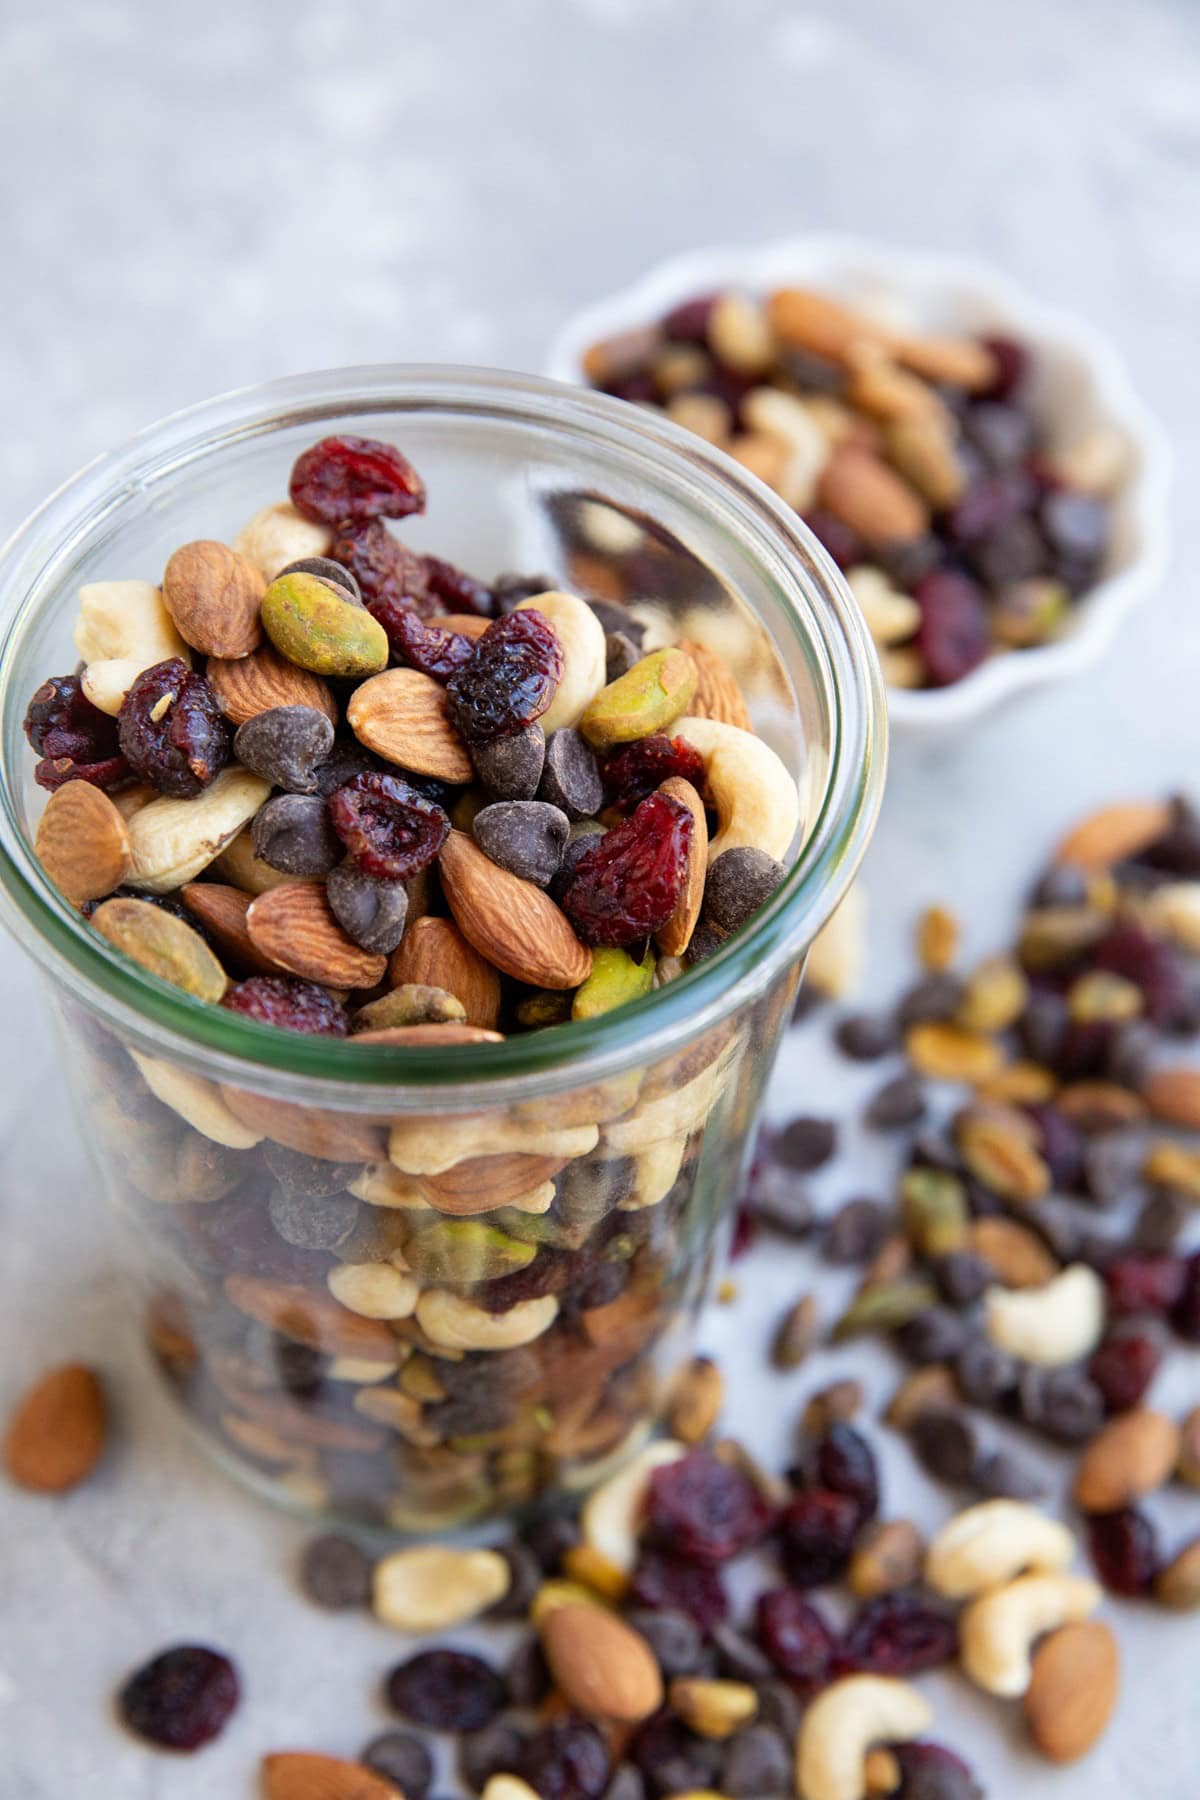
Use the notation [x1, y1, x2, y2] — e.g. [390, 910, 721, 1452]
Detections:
[545, 236, 1169, 734]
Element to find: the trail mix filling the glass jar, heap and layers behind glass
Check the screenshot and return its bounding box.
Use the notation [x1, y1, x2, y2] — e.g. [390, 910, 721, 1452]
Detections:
[25, 437, 799, 1530]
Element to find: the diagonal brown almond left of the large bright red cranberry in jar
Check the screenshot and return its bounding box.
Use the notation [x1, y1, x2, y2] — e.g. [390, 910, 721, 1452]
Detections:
[438, 832, 592, 1004]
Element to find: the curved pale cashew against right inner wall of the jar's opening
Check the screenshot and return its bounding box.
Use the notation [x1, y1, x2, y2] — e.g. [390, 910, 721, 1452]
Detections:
[673, 713, 801, 866]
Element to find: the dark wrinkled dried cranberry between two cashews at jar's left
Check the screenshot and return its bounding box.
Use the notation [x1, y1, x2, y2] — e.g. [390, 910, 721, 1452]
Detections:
[117, 657, 234, 799]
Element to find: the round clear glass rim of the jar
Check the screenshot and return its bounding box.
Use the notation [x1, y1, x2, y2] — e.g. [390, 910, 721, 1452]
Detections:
[0, 364, 887, 1109]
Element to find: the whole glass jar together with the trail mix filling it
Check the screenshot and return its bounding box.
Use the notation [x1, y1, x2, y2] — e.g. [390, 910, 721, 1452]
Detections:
[0, 369, 885, 1534]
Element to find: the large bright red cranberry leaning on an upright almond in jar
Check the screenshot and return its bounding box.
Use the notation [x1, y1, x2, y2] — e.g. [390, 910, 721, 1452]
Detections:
[561, 794, 693, 949]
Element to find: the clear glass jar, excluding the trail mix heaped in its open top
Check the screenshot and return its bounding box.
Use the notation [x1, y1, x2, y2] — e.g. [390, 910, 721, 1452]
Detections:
[0, 367, 885, 1534]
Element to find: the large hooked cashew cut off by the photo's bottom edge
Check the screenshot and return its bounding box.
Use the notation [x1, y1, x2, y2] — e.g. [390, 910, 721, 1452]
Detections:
[795, 1676, 934, 1800]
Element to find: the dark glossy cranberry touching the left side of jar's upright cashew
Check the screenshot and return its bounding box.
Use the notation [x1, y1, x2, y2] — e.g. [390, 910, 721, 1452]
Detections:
[446, 608, 563, 743]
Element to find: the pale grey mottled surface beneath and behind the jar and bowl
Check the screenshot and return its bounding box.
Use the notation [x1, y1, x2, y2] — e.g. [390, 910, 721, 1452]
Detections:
[0, 0, 1200, 1800]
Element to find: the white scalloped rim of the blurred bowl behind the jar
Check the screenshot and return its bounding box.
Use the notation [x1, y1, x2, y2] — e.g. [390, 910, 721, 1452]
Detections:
[543, 232, 1173, 733]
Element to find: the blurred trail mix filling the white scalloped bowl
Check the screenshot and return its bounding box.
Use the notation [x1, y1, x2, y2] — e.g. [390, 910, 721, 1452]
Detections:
[583, 288, 1126, 688]
